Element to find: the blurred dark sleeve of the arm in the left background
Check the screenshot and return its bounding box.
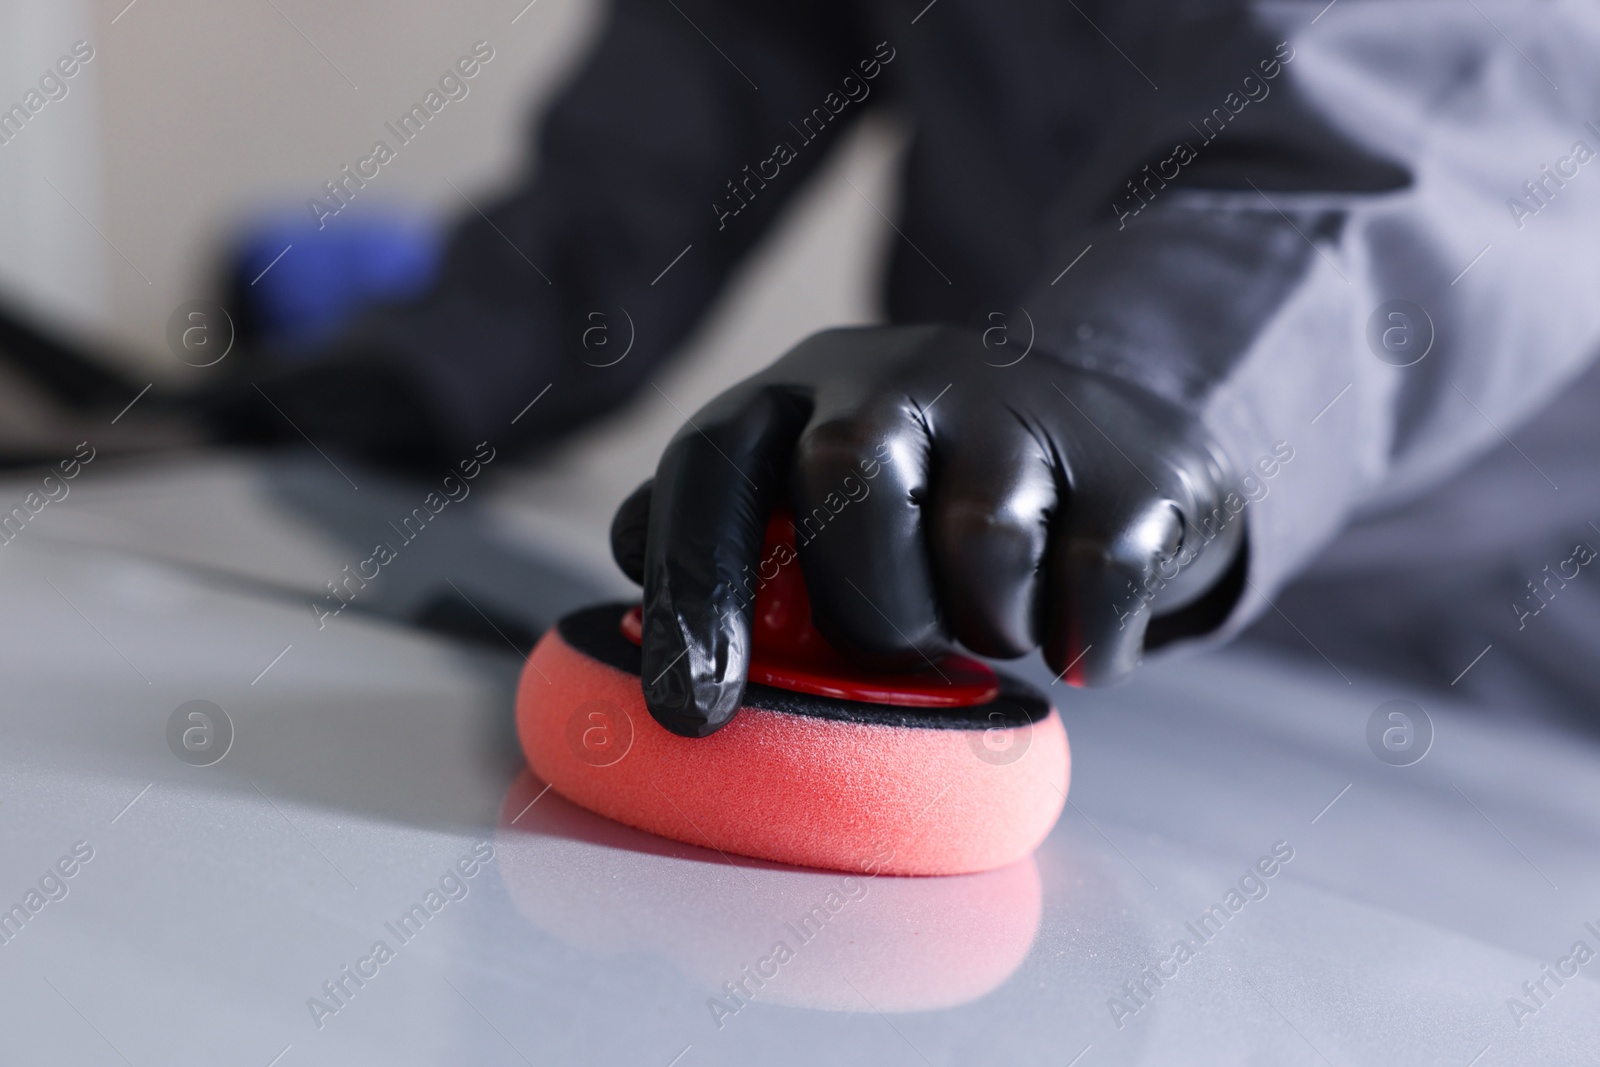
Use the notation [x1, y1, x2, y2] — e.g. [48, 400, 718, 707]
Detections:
[329, 0, 886, 445]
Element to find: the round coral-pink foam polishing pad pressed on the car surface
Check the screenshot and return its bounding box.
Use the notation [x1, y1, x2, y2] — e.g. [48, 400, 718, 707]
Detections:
[517, 608, 1070, 875]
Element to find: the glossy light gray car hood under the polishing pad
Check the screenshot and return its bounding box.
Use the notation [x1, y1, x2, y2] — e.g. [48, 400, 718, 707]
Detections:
[0, 461, 1600, 1067]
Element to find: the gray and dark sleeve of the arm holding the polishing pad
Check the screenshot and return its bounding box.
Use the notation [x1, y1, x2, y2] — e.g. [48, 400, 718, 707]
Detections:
[1024, 0, 1600, 635]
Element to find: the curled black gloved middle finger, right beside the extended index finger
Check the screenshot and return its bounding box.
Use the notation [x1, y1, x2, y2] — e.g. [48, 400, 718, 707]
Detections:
[790, 386, 950, 669]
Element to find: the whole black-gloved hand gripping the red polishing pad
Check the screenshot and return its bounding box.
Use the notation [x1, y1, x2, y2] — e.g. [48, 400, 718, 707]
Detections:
[611, 326, 1243, 737]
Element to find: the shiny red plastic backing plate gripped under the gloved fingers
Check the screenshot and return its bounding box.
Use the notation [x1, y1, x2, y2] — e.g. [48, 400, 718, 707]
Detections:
[621, 512, 1000, 707]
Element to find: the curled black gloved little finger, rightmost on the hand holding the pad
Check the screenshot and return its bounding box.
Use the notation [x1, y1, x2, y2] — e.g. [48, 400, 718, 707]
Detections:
[1043, 493, 1184, 686]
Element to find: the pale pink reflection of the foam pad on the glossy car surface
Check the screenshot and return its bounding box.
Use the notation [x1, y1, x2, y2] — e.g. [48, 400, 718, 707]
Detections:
[494, 771, 1042, 1025]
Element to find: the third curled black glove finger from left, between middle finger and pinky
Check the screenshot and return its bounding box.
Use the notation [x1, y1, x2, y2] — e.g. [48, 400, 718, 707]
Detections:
[925, 416, 1058, 657]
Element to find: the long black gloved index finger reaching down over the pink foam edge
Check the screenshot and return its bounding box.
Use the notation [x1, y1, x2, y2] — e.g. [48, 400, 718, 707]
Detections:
[643, 386, 810, 737]
